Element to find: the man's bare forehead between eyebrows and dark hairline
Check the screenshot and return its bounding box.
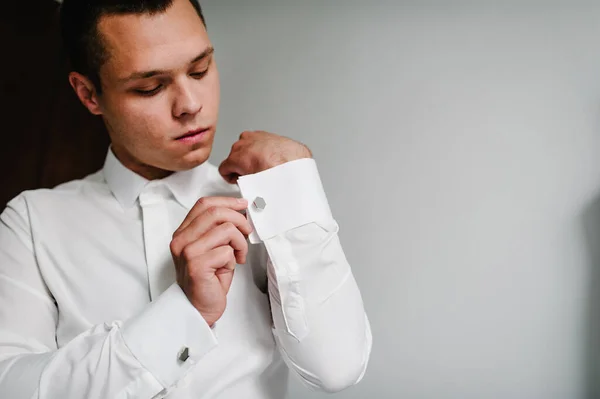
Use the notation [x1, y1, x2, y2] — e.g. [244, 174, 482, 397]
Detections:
[98, 0, 210, 79]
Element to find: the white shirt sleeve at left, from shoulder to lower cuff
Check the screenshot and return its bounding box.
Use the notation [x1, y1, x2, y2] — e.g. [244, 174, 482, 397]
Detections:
[0, 196, 217, 399]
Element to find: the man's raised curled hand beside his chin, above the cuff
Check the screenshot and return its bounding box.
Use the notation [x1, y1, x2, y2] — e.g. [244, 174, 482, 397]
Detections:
[219, 131, 312, 183]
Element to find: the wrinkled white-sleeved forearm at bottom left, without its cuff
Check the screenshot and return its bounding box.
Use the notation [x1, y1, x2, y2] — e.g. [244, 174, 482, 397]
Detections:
[0, 323, 163, 399]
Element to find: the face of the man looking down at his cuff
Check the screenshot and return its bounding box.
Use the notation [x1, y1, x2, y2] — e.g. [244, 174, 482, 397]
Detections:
[92, 0, 219, 178]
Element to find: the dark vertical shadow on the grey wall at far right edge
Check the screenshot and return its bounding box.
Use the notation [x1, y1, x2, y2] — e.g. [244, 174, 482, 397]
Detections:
[582, 194, 600, 399]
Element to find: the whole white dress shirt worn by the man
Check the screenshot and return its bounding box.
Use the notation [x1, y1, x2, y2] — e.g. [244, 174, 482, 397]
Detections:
[0, 150, 371, 399]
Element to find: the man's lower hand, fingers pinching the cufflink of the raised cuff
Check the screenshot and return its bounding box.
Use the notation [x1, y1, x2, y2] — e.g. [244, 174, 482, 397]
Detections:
[170, 197, 252, 326]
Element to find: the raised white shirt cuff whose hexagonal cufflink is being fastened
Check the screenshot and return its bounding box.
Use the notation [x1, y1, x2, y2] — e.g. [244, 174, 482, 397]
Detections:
[238, 158, 332, 244]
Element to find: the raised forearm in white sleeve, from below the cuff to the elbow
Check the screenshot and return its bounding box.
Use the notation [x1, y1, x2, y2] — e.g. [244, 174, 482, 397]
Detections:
[265, 225, 372, 392]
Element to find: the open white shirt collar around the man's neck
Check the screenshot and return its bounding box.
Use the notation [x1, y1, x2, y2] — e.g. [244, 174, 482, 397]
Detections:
[103, 149, 208, 209]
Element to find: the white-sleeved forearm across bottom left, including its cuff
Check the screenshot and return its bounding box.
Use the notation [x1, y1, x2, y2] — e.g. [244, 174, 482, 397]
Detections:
[0, 285, 216, 399]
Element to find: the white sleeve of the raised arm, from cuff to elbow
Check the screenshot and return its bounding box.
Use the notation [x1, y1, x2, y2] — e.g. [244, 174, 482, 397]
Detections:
[238, 158, 372, 392]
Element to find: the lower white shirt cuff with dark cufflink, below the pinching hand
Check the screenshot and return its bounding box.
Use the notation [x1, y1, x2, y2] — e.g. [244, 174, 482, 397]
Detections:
[121, 283, 218, 389]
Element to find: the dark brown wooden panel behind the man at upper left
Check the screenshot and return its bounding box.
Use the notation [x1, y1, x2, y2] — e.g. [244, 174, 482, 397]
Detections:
[0, 0, 108, 207]
